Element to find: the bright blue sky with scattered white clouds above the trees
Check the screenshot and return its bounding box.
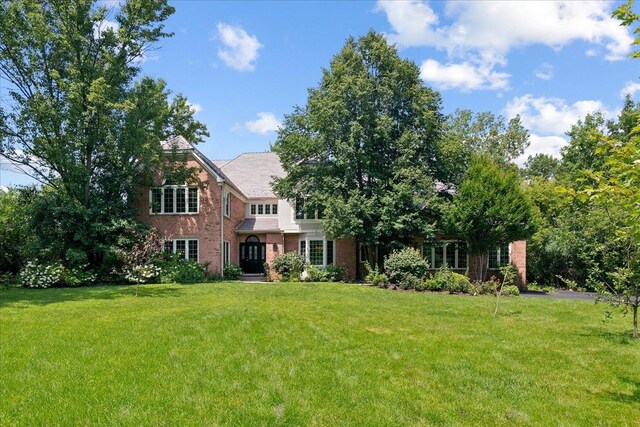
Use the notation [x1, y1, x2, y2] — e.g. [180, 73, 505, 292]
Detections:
[0, 1, 640, 186]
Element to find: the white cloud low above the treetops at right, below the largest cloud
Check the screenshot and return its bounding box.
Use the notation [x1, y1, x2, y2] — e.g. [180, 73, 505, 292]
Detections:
[505, 94, 616, 135]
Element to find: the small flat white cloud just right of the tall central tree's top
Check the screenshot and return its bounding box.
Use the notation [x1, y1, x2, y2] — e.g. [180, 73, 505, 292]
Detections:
[420, 59, 510, 92]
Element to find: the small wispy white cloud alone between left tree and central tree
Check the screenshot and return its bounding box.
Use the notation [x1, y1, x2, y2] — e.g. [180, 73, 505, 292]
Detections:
[218, 22, 262, 71]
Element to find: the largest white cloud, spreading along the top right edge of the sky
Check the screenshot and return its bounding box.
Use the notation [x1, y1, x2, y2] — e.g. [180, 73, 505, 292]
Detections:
[377, 0, 633, 91]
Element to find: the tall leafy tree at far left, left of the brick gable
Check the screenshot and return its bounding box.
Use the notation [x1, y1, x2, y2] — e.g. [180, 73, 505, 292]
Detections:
[0, 0, 207, 270]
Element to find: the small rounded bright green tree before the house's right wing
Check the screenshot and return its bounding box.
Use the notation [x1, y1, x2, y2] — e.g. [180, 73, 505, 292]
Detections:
[449, 155, 534, 280]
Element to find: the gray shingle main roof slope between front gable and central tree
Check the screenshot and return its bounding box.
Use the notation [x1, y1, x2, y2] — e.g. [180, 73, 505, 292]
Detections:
[220, 152, 285, 198]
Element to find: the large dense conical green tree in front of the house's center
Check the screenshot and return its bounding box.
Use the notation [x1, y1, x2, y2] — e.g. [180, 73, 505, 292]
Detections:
[273, 31, 442, 278]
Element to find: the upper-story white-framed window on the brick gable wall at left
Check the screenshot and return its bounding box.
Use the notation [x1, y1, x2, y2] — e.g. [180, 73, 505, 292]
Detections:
[149, 181, 199, 214]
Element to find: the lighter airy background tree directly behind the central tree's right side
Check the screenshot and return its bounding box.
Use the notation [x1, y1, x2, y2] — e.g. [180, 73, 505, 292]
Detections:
[440, 110, 529, 185]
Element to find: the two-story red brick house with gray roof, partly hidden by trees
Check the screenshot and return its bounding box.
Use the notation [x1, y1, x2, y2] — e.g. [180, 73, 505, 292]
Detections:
[135, 136, 526, 285]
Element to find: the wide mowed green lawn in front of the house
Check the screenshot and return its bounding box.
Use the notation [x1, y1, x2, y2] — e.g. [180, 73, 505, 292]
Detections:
[0, 283, 640, 426]
